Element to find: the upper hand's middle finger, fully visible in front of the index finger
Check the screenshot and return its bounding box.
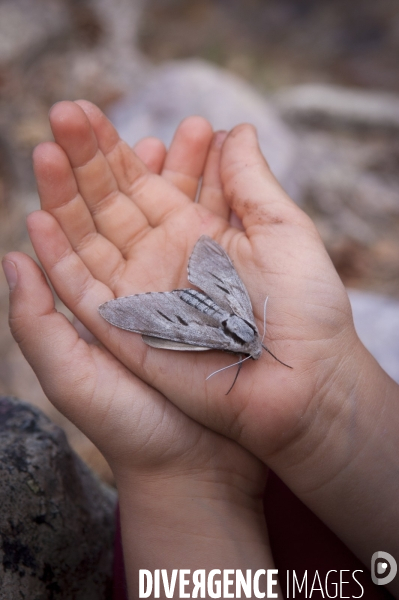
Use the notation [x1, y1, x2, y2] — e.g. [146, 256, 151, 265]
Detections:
[50, 102, 152, 254]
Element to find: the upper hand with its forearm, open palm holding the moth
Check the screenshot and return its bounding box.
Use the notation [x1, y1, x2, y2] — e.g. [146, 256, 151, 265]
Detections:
[3, 103, 399, 592]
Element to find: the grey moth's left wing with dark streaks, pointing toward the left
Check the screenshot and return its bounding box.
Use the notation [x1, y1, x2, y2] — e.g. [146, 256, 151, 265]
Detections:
[99, 290, 249, 353]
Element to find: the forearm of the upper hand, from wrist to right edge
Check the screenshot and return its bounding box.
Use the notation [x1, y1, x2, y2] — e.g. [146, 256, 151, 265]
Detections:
[269, 332, 399, 593]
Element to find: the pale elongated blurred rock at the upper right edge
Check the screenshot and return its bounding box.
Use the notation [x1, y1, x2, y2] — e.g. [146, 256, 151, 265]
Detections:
[274, 84, 399, 132]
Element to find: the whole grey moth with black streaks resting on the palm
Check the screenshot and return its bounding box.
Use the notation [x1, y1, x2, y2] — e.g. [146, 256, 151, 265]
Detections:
[99, 235, 292, 393]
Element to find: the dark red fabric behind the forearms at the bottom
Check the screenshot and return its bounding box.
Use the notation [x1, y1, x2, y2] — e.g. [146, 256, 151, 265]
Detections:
[112, 472, 393, 600]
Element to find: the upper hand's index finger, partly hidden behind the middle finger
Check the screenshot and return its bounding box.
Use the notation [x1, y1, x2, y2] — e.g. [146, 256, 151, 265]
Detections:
[75, 100, 194, 227]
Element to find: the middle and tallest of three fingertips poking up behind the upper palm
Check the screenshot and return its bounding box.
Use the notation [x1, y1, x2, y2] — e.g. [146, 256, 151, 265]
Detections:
[162, 117, 213, 200]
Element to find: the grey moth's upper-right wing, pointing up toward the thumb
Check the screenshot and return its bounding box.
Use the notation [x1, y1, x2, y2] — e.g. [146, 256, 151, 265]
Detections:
[188, 235, 256, 330]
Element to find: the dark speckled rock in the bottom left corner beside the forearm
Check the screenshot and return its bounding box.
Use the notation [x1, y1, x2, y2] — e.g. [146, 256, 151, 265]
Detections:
[0, 396, 116, 600]
